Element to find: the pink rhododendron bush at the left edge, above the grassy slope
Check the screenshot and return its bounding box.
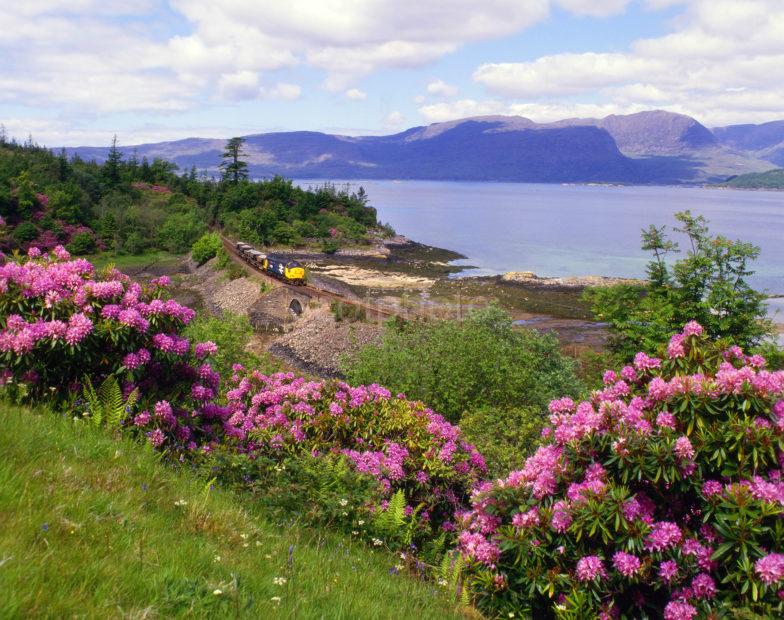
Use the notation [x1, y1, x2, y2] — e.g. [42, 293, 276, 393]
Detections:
[0, 246, 225, 449]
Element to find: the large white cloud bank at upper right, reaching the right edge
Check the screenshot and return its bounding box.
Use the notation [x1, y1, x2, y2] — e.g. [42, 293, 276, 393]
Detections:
[468, 0, 784, 125]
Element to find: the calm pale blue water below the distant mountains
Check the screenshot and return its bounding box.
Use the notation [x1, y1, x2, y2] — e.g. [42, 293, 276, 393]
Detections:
[300, 181, 784, 294]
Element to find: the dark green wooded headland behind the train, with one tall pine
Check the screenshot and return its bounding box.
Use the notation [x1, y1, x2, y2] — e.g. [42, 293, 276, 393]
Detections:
[0, 131, 377, 254]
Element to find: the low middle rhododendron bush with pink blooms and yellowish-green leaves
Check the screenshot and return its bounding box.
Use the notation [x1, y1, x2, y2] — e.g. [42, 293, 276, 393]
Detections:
[214, 366, 485, 530]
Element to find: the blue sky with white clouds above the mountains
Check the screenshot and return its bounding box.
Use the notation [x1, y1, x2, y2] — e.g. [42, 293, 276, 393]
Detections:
[0, 0, 784, 147]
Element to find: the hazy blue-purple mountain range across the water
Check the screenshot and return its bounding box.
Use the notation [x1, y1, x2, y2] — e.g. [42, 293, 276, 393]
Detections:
[66, 110, 784, 184]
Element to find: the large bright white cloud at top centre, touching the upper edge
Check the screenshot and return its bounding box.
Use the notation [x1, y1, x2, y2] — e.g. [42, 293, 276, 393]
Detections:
[172, 0, 550, 91]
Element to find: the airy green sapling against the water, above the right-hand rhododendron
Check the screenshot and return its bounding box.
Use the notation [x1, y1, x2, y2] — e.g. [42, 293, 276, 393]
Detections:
[585, 211, 771, 359]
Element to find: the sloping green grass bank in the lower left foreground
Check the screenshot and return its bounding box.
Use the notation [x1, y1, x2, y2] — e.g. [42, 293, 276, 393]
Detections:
[0, 403, 461, 619]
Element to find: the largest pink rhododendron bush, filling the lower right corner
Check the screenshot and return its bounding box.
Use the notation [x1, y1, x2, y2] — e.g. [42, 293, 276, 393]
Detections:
[459, 322, 784, 620]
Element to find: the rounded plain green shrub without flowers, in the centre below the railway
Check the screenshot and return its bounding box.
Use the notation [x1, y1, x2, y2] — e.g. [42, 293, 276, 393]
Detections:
[342, 306, 579, 422]
